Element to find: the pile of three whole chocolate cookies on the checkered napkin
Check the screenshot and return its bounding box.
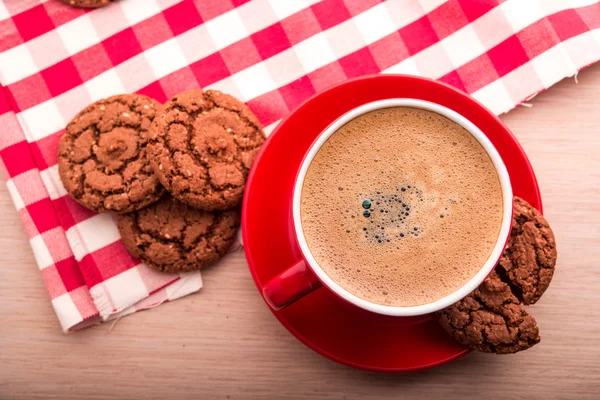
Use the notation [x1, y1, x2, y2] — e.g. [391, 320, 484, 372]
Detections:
[58, 90, 265, 272]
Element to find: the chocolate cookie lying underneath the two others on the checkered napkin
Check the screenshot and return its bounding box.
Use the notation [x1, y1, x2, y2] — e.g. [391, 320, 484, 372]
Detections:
[117, 195, 240, 272]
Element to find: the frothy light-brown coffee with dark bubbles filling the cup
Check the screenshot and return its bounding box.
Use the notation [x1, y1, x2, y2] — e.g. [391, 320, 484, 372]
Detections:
[300, 107, 503, 306]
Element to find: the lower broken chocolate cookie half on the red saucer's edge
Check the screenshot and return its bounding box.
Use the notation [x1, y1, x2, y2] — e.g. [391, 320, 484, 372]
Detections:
[439, 272, 540, 354]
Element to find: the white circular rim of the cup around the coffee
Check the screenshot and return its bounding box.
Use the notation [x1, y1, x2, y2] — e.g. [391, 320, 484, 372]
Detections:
[292, 98, 512, 316]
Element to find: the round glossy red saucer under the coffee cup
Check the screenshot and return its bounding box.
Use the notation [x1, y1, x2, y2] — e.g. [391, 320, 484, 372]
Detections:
[242, 75, 542, 372]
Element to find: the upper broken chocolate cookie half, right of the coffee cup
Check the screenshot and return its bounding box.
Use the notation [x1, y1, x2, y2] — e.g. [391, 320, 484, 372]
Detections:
[497, 197, 556, 304]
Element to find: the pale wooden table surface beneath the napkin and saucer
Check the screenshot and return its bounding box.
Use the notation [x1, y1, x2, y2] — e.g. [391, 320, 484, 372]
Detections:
[0, 65, 600, 400]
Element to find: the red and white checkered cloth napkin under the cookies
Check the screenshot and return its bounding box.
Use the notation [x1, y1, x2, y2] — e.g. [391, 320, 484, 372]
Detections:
[0, 0, 600, 331]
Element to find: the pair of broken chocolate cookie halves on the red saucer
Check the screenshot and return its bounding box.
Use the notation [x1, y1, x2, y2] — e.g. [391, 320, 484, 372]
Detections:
[439, 197, 557, 354]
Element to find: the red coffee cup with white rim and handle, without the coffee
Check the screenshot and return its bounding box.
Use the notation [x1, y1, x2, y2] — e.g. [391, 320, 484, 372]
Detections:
[263, 98, 513, 316]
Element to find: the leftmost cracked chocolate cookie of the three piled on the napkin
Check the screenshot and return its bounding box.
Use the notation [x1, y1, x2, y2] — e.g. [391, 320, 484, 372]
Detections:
[58, 94, 164, 213]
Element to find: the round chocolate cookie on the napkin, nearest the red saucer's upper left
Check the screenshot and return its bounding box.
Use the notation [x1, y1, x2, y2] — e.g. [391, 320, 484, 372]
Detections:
[148, 90, 265, 210]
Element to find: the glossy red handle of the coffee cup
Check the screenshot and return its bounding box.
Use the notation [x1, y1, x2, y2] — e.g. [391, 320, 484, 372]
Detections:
[262, 260, 321, 310]
